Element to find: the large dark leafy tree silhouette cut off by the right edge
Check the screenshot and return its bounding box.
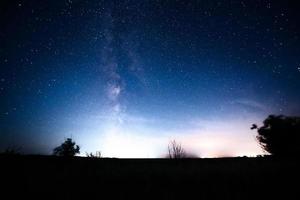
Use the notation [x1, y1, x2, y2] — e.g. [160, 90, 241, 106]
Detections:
[251, 115, 300, 156]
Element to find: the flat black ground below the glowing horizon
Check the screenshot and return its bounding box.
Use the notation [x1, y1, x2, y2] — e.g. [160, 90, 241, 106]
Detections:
[0, 155, 300, 200]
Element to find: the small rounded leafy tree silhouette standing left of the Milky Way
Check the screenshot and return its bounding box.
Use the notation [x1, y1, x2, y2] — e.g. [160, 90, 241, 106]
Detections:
[53, 138, 80, 157]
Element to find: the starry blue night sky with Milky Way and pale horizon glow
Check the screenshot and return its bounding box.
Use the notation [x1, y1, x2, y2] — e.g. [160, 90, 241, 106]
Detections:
[0, 0, 300, 158]
